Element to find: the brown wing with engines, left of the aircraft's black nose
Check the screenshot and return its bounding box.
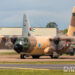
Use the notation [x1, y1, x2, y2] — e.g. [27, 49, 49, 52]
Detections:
[0, 36, 21, 49]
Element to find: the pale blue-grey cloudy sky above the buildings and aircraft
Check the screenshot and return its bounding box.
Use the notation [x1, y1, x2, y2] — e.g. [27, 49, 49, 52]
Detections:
[0, 0, 75, 29]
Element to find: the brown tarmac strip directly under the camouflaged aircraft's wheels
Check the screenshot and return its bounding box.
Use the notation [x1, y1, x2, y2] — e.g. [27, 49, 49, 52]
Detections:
[0, 55, 75, 62]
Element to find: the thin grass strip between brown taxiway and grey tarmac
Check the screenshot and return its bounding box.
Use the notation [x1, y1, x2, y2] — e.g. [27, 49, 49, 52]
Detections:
[0, 61, 75, 64]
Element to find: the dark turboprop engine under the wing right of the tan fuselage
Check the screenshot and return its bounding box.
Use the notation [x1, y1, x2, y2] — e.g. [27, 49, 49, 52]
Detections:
[50, 37, 70, 55]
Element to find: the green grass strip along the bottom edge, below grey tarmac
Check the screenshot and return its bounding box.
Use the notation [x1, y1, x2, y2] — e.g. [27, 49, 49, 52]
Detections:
[0, 69, 75, 75]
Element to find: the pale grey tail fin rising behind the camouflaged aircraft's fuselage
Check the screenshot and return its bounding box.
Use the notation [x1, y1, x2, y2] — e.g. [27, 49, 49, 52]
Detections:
[22, 14, 30, 37]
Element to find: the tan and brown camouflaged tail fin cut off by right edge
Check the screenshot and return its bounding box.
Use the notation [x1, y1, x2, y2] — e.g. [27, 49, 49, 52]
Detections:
[67, 6, 75, 36]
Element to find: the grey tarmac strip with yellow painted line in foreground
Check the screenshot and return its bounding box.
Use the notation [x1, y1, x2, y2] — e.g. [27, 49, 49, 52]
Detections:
[0, 64, 75, 70]
